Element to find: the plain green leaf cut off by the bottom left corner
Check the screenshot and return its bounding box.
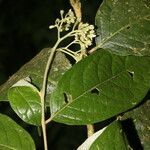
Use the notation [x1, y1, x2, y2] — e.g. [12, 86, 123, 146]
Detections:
[0, 114, 35, 150]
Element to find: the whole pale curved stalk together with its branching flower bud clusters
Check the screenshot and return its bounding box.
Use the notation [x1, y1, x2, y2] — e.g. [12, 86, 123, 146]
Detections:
[40, 9, 96, 150]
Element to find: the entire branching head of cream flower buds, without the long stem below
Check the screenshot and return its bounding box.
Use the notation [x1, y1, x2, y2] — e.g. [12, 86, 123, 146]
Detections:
[49, 9, 96, 62]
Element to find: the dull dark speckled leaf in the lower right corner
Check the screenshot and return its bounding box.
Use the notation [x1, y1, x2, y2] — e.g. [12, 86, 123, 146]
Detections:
[122, 100, 150, 150]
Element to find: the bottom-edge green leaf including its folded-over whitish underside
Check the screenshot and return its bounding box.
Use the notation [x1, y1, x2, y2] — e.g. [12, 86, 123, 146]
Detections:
[77, 121, 128, 150]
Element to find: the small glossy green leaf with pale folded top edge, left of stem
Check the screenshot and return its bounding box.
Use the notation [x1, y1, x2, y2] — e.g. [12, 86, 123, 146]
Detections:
[8, 79, 41, 126]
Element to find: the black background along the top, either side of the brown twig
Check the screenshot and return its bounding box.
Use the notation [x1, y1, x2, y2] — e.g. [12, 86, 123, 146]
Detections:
[0, 0, 101, 83]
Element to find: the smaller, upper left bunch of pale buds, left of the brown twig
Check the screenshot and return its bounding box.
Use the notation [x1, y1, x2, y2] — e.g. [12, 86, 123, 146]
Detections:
[49, 9, 76, 32]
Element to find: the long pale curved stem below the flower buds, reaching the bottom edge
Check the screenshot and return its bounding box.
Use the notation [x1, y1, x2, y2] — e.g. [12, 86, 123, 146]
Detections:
[40, 40, 61, 150]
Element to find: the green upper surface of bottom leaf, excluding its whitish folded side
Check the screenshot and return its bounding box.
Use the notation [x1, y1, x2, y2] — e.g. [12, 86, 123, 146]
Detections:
[89, 122, 129, 150]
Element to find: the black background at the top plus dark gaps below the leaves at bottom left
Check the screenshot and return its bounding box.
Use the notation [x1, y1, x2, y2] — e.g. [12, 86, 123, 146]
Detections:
[0, 0, 101, 150]
